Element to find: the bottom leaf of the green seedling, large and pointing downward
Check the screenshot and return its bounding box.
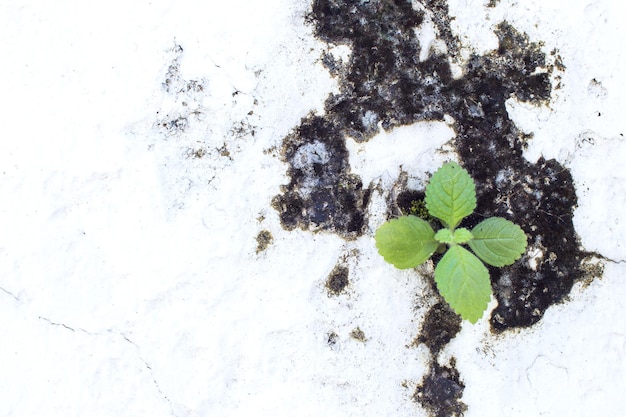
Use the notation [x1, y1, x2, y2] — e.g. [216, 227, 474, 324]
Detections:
[435, 245, 491, 323]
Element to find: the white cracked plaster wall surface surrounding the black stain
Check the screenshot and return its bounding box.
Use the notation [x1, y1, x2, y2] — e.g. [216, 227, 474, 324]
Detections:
[0, 0, 626, 417]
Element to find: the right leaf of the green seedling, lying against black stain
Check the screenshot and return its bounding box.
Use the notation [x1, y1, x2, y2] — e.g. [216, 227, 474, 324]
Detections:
[468, 217, 526, 266]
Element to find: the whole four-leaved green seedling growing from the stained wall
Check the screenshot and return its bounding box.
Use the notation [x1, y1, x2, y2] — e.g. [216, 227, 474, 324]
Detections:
[375, 162, 526, 323]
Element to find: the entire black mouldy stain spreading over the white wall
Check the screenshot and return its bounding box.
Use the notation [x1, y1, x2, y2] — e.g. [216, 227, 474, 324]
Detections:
[273, 0, 600, 416]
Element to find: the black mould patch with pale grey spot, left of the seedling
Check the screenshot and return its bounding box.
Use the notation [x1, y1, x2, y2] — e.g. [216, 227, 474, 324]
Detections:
[272, 115, 370, 238]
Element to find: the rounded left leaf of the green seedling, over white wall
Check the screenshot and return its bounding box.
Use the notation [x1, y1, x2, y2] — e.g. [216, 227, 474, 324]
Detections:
[375, 216, 439, 269]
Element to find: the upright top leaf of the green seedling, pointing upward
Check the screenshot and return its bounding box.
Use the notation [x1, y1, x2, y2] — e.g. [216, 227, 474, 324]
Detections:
[425, 162, 476, 230]
